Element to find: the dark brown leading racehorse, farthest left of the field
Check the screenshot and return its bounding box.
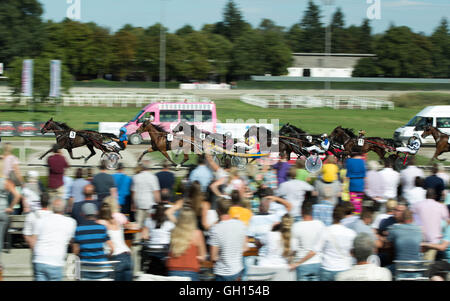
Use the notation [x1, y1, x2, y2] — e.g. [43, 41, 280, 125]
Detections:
[39, 117, 117, 163]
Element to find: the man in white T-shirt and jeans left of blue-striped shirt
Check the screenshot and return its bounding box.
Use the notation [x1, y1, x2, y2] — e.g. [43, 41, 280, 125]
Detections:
[31, 199, 76, 281]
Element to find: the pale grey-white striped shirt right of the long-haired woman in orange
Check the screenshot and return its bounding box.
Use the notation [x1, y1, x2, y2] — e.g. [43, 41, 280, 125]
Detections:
[210, 219, 246, 276]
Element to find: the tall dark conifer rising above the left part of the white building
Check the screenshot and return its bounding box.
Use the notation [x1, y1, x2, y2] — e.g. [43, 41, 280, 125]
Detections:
[300, 0, 325, 52]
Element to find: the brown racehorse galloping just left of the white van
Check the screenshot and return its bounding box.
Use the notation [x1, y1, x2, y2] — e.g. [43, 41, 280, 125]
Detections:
[330, 126, 395, 160]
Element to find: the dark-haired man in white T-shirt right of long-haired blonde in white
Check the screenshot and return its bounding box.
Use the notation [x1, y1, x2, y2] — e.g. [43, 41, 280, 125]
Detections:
[290, 201, 326, 281]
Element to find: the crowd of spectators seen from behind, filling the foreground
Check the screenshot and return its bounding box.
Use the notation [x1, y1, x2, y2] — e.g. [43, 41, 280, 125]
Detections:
[0, 144, 450, 281]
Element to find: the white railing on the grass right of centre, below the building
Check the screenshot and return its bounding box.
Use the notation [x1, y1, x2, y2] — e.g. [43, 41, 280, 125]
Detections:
[241, 94, 395, 110]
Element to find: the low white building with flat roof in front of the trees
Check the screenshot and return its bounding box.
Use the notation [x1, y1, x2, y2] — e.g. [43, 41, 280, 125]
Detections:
[288, 53, 375, 77]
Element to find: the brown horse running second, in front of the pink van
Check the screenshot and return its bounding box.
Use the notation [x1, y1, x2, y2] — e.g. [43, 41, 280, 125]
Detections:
[136, 120, 189, 167]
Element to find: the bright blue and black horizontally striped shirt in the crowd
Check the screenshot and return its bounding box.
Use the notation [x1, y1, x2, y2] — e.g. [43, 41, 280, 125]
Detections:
[75, 220, 110, 261]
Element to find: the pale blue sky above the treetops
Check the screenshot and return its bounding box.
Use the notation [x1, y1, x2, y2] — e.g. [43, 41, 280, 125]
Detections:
[39, 0, 450, 34]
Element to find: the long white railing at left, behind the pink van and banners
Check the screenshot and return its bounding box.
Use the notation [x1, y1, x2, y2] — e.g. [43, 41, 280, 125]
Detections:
[0, 92, 210, 107]
